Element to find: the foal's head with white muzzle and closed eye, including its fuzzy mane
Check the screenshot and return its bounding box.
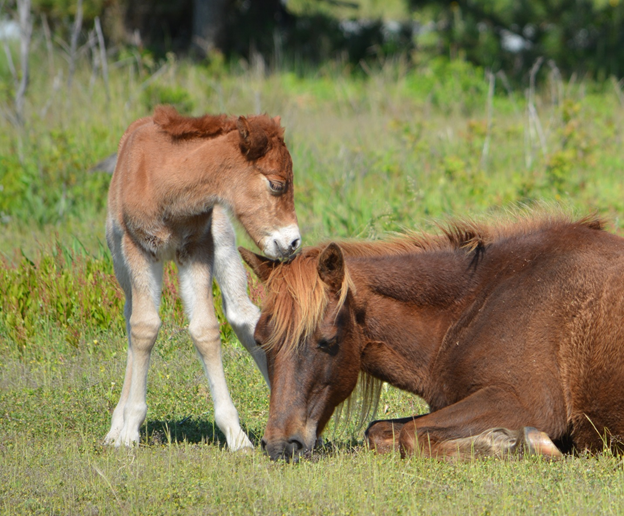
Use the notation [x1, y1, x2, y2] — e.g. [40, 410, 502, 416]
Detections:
[154, 106, 301, 259]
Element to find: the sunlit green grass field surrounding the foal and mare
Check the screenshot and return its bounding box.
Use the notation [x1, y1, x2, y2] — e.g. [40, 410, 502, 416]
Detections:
[0, 44, 624, 514]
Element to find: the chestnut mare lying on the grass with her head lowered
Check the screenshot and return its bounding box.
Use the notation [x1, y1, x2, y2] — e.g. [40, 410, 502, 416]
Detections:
[239, 216, 624, 459]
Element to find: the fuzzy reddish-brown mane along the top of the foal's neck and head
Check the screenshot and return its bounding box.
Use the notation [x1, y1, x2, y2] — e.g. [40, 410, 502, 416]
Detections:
[152, 106, 284, 138]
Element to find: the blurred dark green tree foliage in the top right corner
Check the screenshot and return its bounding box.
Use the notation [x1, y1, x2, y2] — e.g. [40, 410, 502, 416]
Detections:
[410, 0, 624, 78]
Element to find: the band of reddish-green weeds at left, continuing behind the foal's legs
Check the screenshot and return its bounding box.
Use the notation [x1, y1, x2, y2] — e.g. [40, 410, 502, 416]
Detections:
[0, 244, 236, 353]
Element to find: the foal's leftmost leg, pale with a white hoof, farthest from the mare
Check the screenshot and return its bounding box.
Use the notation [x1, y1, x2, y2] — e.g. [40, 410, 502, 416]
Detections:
[105, 230, 162, 446]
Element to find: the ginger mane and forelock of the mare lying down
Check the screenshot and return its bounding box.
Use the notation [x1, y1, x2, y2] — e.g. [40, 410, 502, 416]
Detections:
[264, 212, 605, 425]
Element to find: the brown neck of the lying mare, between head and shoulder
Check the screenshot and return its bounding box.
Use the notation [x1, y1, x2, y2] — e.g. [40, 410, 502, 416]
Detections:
[348, 251, 472, 402]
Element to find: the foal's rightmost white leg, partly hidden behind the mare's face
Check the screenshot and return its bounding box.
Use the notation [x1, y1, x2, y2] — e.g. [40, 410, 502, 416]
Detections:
[211, 205, 269, 385]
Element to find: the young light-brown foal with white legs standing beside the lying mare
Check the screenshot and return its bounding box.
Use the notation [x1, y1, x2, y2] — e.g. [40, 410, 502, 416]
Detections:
[105, 106, 300, 450]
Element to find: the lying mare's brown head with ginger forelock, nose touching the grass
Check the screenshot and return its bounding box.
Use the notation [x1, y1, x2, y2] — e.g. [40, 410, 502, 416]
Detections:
[240, 243, 362, 460]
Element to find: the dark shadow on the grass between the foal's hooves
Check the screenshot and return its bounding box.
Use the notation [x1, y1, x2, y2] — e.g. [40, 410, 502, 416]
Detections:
[141, 417, 263, 448]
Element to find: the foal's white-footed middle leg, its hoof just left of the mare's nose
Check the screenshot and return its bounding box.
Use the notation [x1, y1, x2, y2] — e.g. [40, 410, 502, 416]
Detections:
[178, 251, 253, 451]
